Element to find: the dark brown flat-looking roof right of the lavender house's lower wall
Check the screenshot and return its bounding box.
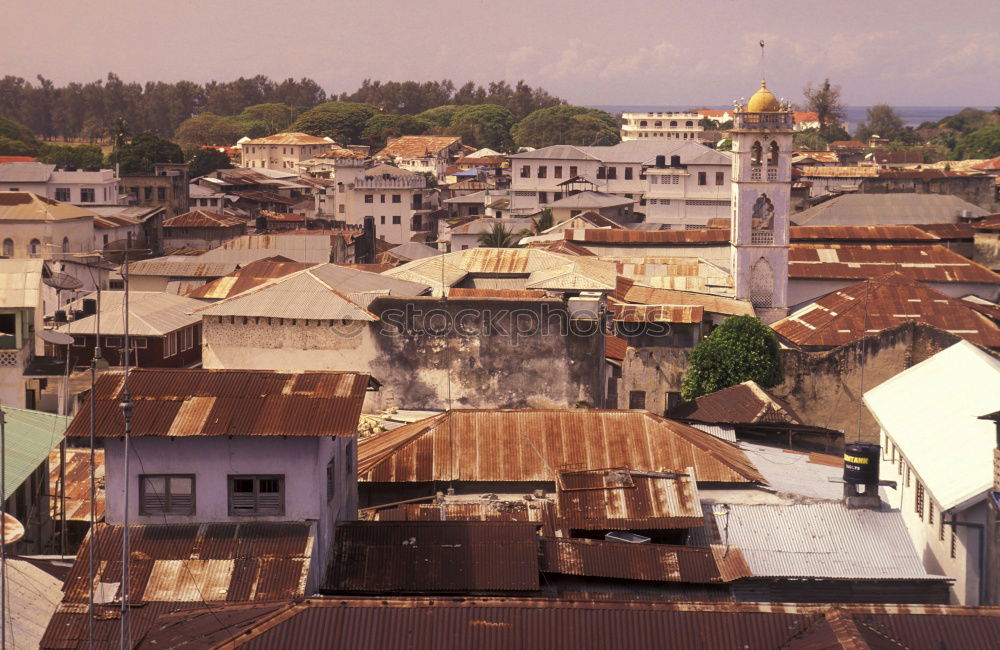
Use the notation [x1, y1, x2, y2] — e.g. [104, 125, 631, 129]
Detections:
[324, 521, 538, 593]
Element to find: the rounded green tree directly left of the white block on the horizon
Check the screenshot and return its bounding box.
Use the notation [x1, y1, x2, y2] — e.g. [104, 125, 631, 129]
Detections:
[512, 106, 620, 148]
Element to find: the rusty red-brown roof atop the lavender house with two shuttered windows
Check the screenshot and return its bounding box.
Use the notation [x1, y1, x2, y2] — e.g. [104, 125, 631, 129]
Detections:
[66, 368, 369, 438]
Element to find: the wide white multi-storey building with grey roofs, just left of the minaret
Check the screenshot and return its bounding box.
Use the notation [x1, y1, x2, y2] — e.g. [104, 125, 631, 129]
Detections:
[510, 138, 731, 229]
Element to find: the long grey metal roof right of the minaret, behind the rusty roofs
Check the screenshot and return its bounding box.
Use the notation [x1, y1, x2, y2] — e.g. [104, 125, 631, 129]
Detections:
[790, 193, 988, 226]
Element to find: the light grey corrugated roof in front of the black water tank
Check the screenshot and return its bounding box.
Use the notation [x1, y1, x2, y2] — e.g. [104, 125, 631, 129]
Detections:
[714, 503, 940, 580]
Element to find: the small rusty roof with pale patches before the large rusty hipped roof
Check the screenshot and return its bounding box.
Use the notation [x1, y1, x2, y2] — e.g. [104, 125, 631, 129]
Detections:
[556, 468, 705, 530]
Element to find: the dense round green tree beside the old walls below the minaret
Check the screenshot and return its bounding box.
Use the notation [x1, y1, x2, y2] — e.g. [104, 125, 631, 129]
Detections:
[681, 316, 784, 400]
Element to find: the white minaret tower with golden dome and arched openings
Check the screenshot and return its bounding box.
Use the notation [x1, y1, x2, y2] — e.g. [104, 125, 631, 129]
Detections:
[730, 81, 794, 323]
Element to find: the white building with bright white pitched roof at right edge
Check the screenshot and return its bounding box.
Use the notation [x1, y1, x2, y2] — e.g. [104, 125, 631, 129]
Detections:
[864, 341, 1000, 605]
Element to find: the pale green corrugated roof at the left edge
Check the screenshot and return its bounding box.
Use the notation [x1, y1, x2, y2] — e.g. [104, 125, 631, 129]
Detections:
[2, 406, 69, 499]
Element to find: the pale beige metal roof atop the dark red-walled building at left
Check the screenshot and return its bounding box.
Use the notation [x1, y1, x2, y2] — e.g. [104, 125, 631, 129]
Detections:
[57, 291, 204, 336]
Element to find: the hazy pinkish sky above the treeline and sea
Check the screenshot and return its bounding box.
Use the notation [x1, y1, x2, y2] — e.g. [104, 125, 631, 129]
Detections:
[0, 0, 1000, 106]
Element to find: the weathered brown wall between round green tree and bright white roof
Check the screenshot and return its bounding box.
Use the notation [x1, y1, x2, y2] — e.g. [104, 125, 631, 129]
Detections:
[770, 322, 961, 443]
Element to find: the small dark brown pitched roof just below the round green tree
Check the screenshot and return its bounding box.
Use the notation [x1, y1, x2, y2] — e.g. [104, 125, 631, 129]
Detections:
[669, 381, 802, 424]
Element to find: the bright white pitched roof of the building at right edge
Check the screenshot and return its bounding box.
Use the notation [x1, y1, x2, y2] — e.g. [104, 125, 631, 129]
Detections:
[864, 341, 1000, 512]
